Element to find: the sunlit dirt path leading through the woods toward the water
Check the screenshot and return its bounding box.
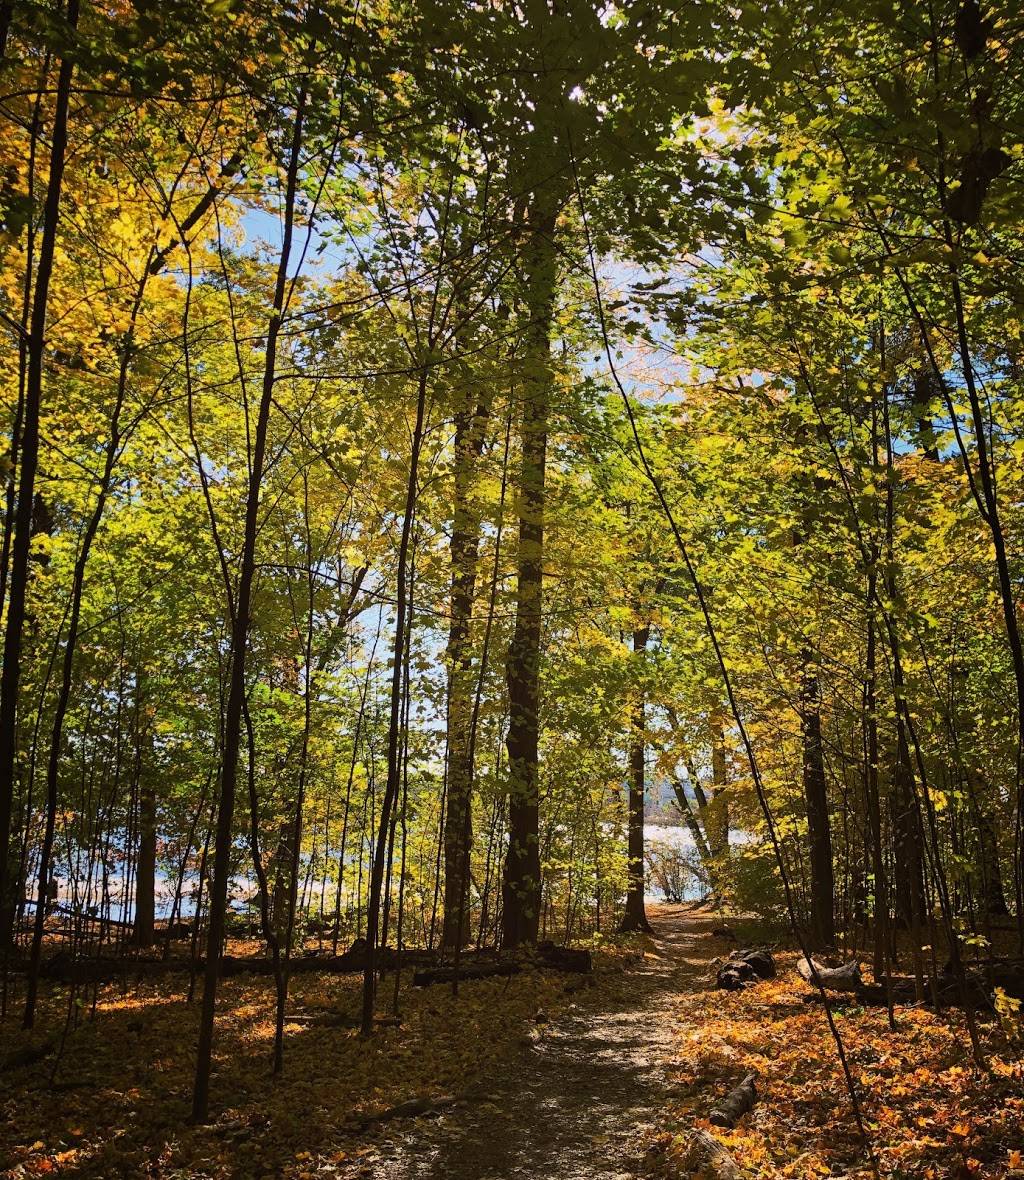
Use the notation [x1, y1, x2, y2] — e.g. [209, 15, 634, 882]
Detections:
[351, 906, 714, 1180]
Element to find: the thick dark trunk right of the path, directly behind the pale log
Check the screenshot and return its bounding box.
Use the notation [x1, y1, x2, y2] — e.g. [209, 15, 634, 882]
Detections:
[800, 665, 835, 950]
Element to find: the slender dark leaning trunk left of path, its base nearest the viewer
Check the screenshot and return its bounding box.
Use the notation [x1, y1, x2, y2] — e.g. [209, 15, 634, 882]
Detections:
[192, 85, 307, 1122]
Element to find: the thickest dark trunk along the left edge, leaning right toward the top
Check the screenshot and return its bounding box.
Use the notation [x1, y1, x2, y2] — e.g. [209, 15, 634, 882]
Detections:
[0, 0, 79, 943]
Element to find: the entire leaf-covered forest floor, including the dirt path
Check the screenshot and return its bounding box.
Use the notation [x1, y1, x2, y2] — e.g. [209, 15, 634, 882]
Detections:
[0, 906, 1024, 1180]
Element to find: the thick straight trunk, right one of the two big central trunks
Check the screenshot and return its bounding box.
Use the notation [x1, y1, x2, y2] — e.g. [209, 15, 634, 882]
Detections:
[501, 192, 556, 949]
